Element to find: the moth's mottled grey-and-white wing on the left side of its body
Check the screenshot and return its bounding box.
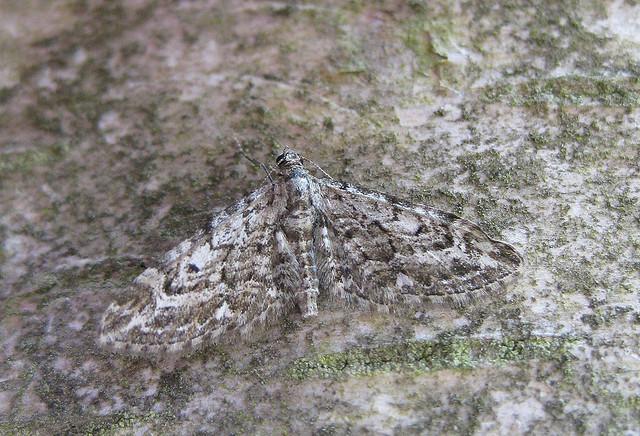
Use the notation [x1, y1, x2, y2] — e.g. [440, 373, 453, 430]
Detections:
[100, 185, 294, 353]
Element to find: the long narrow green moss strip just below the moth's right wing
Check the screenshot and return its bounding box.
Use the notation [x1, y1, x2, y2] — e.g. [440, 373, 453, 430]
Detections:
[288, 337, 574, 380]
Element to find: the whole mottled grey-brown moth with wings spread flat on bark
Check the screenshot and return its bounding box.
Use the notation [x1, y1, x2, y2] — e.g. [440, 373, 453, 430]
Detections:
[99, 150, 523, 353]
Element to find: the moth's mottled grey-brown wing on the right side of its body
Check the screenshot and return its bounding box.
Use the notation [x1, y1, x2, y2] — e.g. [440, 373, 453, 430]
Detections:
[316, 179, 523, 311]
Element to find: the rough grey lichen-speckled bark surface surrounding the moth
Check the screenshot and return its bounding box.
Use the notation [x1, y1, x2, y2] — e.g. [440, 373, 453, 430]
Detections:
[0, 0, 640, 434]
